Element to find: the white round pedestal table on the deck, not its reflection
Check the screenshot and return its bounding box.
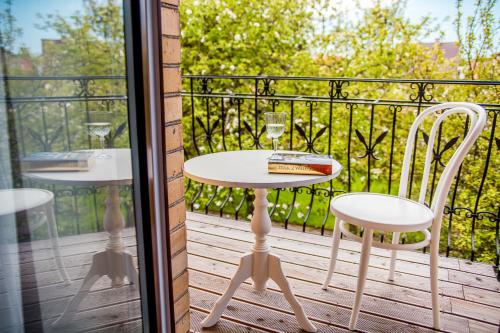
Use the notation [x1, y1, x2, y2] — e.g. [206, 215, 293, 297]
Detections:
[184, 150, 342, 332]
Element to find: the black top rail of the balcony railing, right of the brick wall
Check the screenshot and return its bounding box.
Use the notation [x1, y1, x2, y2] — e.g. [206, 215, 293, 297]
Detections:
[182, 74, 500, 86]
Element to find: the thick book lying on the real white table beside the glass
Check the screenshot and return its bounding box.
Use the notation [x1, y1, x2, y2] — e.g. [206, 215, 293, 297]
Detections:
[267, 153, 333, 175]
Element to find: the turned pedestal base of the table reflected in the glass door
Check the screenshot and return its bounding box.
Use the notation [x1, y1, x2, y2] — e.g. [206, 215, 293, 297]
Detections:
[52, 185, 139, 327]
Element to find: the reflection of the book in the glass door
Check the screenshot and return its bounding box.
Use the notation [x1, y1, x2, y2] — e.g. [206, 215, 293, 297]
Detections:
[21, 151, 95, 172]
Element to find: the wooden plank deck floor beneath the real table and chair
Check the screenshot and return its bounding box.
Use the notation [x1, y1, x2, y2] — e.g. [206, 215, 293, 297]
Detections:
[188, 214, 500, 332]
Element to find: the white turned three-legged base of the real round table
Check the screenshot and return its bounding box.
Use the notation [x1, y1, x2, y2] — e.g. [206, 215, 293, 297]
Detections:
[201, 189, 317, 332]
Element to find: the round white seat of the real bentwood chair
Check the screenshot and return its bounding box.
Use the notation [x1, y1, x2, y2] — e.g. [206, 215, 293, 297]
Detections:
[330, 193, 434, 232]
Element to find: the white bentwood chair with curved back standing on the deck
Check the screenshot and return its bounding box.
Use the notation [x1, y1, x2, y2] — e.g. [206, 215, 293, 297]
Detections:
[323, 102, 487, 330]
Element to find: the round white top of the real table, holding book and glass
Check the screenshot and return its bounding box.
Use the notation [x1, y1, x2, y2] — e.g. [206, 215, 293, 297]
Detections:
[184, 150, 342, 189]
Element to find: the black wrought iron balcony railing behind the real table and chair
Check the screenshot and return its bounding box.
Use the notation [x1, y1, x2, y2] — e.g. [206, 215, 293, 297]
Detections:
[183, 75, 500, 266]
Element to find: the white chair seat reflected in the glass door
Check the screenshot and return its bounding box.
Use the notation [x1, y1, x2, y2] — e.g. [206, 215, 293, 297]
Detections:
[0, 188, 54, 216]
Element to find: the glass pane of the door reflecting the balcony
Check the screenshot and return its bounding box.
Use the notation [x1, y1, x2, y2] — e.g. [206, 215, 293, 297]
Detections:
[0, 0, 162, 332]
